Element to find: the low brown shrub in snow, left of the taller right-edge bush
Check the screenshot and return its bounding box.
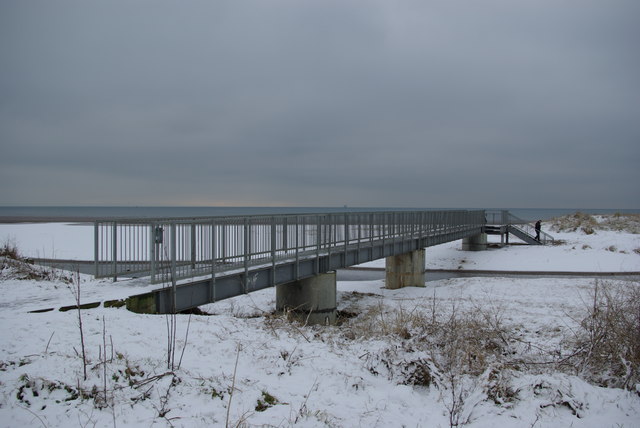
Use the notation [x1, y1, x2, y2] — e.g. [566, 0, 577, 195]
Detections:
[352, 302, 511, 389]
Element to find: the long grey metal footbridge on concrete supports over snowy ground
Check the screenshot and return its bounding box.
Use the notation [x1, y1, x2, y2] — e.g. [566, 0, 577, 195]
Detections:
[94, 210, 552, 322]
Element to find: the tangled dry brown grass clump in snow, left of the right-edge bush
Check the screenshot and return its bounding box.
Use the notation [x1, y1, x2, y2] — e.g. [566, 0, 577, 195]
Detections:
[341, 298, 516, 427]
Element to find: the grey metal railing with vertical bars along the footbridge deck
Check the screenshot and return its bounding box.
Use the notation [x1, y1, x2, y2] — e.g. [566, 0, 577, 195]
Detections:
[95, 210, 485, 283]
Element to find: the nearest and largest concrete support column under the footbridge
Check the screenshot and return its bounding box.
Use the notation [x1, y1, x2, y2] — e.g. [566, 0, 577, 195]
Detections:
[276, 272, 337, 325]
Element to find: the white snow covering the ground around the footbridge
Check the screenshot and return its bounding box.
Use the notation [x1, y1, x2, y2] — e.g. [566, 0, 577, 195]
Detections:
[0, 224, 640, 428]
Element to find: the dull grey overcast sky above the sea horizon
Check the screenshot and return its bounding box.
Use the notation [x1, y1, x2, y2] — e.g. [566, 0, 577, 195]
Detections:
[0, 0, 640, 208]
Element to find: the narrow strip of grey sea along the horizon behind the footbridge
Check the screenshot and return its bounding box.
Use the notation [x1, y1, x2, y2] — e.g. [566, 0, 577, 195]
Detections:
[0, 206, 640, 223]
